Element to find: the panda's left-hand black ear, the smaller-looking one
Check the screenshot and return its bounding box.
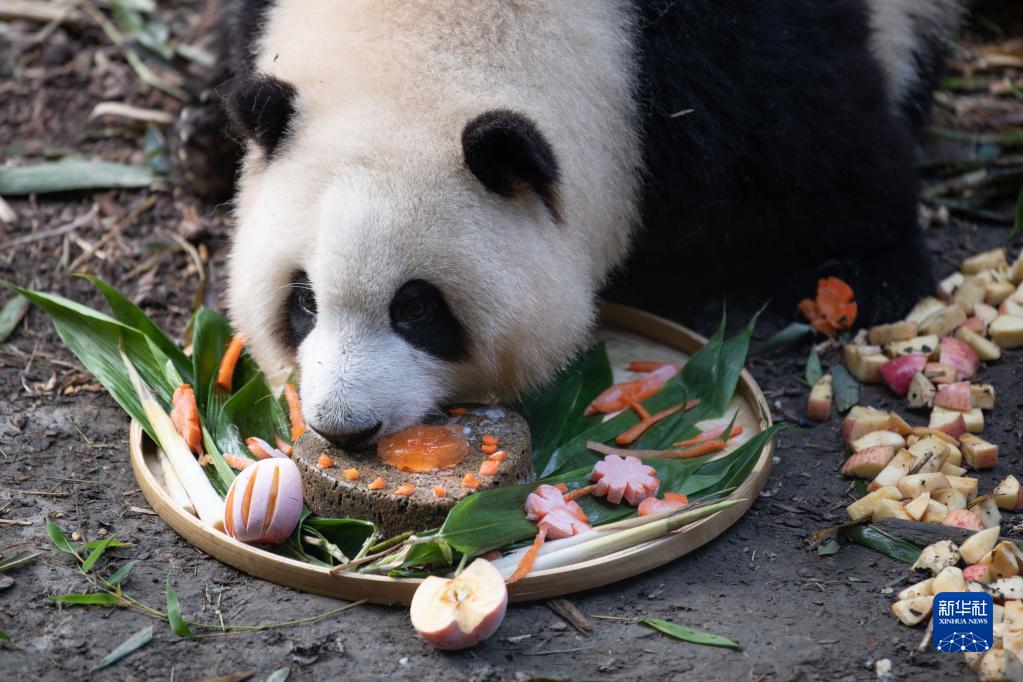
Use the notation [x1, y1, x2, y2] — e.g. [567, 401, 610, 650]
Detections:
[226, 76, 295, 156]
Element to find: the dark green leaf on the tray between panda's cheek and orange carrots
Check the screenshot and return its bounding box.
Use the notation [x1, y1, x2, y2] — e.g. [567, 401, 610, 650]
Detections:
[512, 343, 612, 471]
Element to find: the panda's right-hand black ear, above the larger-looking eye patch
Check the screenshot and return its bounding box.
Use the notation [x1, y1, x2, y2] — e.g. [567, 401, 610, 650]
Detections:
[461, 109, 561, 222]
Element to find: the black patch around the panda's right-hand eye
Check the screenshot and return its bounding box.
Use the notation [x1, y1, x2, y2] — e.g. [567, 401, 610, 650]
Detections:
[389, 279, 469, 362]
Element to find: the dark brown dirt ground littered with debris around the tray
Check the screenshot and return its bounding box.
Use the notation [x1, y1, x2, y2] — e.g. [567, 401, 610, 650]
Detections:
[6, 3, 1023, 681]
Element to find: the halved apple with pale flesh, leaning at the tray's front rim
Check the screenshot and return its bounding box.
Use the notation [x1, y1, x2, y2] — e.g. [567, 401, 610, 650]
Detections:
[409, 559, 508, 650]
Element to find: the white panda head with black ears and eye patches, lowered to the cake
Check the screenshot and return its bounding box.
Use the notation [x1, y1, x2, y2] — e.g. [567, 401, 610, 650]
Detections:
[219, 78, 605, 449]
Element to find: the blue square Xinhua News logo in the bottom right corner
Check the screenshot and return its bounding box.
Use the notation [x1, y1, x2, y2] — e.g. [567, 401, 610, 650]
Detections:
[932, 592, 994, 653]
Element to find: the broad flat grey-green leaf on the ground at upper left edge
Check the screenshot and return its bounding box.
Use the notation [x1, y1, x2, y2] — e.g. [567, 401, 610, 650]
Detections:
[0, 158, 158, 195]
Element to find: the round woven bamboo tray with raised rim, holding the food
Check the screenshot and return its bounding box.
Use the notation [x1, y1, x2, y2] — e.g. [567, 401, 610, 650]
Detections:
[129, 305, 773, 604]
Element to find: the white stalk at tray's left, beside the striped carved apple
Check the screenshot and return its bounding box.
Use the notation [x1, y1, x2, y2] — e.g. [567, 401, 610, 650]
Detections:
[121, 351, 224, 531]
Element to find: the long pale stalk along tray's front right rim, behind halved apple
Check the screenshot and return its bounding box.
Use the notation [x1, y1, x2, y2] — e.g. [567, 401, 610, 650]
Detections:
[493, 500, 744, 578]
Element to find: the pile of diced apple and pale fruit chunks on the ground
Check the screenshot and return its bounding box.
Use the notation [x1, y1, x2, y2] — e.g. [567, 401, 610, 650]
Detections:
[807, 248, 1023, 680]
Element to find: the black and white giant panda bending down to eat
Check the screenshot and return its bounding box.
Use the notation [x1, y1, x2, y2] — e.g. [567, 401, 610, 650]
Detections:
[195, 0, 960, 450]
